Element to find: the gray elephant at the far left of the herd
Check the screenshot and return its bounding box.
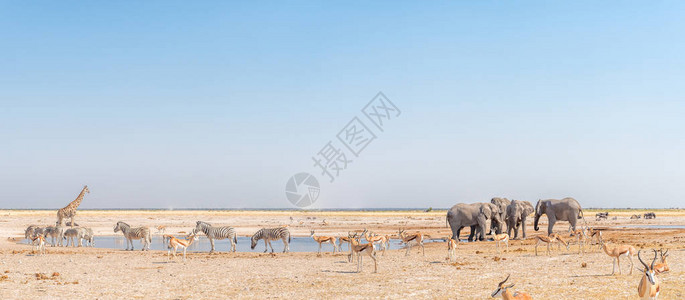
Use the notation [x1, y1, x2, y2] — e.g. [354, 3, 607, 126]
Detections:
[446, 203, 502, 241]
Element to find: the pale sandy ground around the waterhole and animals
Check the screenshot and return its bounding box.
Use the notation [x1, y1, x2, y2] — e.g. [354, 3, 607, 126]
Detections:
[0, 210, 685, 299]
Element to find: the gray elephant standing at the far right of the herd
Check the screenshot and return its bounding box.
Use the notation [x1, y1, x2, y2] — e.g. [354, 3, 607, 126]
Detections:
[533, 197, 583, 234]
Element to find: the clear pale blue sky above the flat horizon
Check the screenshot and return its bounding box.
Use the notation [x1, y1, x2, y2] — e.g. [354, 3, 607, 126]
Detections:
[0, 1, 685, 208]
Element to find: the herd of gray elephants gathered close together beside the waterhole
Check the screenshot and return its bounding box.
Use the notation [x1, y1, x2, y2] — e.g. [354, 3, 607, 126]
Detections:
[447, 197, 583, 242]
